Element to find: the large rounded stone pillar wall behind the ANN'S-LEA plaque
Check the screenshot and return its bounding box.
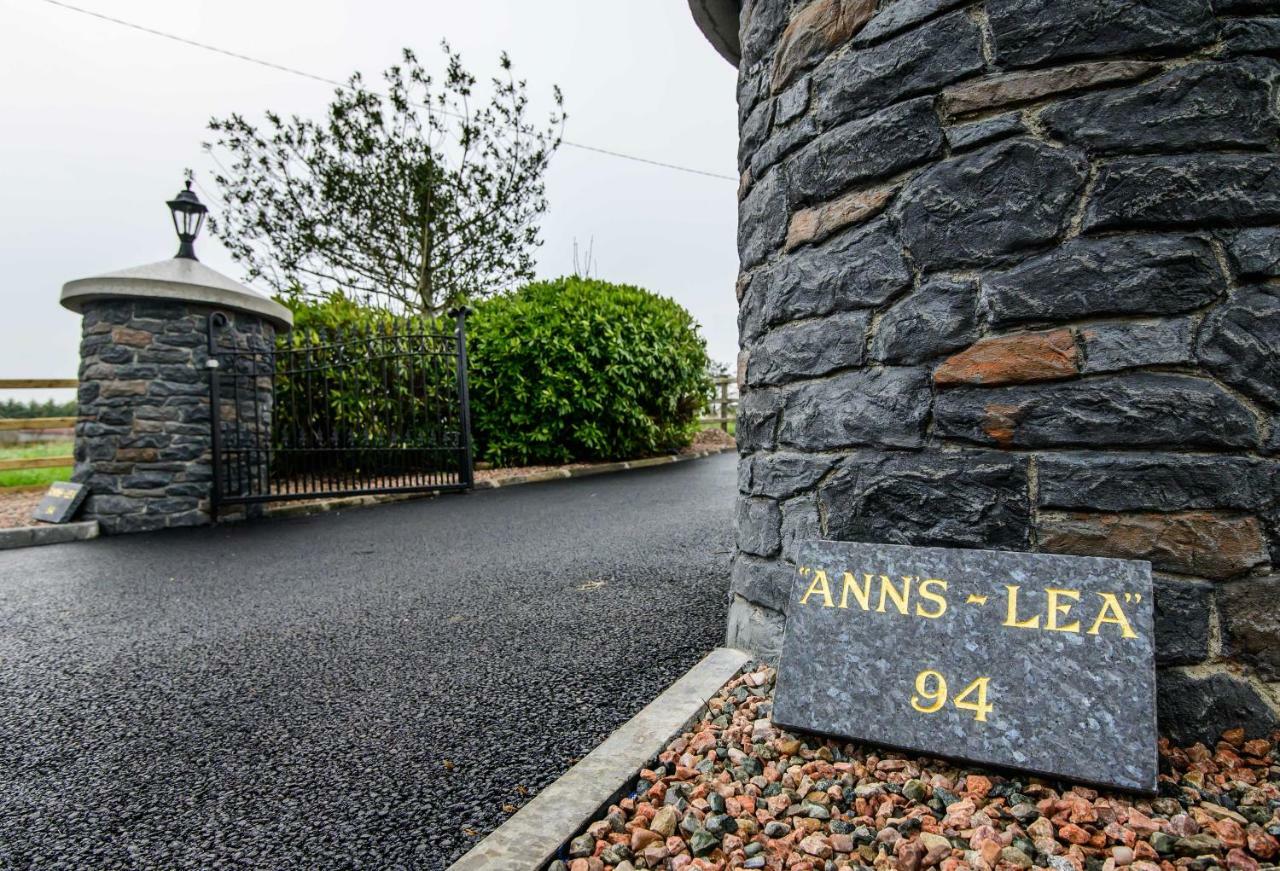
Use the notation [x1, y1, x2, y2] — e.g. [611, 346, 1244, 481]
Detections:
[730, 0, 1280, 739]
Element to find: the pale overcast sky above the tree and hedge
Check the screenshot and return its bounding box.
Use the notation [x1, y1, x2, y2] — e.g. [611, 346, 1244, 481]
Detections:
[0, 0, 737, 398]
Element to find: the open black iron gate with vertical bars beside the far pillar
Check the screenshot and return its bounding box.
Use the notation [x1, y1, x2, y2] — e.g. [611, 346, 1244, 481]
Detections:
[209, 309, 474, 516]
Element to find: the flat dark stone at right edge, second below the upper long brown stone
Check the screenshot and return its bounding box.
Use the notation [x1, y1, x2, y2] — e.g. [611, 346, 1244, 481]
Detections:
[1084, 154, 1280, 232]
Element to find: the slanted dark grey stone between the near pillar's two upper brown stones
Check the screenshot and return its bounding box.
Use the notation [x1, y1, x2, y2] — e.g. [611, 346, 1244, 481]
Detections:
[813, 12, 984, 127]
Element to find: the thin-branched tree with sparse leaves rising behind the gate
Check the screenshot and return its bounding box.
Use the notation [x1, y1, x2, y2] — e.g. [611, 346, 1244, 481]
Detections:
[205, 44, 564, 314]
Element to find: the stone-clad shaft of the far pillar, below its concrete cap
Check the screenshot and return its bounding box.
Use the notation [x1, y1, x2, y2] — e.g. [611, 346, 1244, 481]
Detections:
[73, 300, 274, 533]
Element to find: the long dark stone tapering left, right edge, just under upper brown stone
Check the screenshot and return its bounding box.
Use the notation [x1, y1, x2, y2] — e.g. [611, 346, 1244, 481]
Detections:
[1041, 61, 1277, 154]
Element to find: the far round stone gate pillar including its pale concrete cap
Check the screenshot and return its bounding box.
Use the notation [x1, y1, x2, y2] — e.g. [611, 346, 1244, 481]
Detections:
[61, 257, 293, 534]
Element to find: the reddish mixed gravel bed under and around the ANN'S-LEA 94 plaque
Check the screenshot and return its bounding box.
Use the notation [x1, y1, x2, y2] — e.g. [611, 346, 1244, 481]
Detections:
[563, 667, 1280, 871]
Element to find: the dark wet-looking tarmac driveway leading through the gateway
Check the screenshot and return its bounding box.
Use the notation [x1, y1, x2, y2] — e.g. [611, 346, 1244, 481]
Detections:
[0, 453, 736, 868]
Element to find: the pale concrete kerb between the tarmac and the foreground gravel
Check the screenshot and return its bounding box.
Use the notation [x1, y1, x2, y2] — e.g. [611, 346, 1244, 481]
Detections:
[449, 647, 753, 871]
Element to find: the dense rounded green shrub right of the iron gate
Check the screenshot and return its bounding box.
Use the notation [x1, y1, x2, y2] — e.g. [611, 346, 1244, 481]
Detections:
[467, 277, 708, 465]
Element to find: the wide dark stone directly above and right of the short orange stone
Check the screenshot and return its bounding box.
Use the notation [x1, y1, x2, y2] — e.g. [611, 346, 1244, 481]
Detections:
[982, 234, 1226, 325]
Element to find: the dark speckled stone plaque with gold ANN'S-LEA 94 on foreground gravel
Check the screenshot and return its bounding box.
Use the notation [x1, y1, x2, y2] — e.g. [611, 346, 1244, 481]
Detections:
[773, 542, 1156, 793]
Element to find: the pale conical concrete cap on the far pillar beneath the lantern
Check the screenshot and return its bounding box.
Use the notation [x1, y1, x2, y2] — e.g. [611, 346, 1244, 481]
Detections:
[60, 257, 293, 330]
